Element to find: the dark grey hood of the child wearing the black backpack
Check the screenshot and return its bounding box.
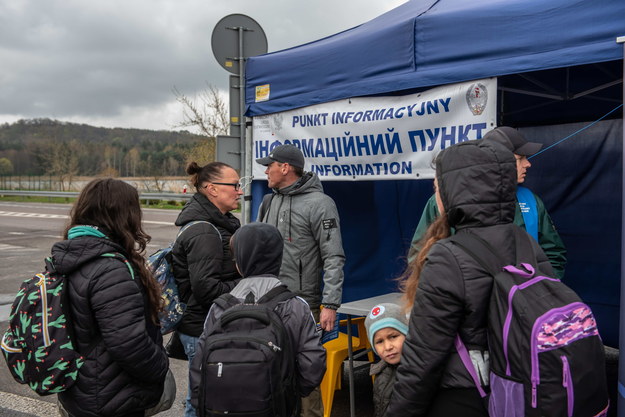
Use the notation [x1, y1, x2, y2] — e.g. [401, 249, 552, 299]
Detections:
[232, 223, 284, 277]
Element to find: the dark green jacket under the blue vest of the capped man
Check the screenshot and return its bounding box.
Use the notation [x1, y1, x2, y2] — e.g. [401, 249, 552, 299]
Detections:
[408, 193, 566, 279]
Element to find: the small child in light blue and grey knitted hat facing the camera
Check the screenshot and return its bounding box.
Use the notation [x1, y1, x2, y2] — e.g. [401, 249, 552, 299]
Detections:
[365, 303, 408, 417]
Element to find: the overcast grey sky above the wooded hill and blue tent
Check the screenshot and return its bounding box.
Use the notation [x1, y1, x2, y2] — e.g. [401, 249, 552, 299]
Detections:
[0, 0, 405, 130]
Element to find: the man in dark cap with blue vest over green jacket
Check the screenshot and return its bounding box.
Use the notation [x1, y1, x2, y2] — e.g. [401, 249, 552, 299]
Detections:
[408, 126, 566, 279]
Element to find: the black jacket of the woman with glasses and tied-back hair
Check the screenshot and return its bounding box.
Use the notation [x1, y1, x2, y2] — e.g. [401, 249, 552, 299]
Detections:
[172, 193, 241, 337]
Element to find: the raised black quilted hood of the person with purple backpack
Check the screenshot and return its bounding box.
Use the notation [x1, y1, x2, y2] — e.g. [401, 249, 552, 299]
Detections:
[436, 140, 517, 230]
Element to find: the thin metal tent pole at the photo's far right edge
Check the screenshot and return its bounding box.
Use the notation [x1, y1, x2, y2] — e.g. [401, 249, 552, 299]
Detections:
[616, 36, 625, 417]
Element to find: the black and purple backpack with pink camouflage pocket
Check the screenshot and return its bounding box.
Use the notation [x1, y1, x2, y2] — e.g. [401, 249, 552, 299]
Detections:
[451, 228, 609, 417]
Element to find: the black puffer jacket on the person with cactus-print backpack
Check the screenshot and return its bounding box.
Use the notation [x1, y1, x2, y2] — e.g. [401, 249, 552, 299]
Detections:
[52, 236, 169, 417]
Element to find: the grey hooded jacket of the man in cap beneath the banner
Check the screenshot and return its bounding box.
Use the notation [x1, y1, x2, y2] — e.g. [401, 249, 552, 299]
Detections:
[258, 172, 345, 308]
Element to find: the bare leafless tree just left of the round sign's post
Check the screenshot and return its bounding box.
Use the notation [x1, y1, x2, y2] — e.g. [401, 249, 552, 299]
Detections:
[173, 84, 230, 165]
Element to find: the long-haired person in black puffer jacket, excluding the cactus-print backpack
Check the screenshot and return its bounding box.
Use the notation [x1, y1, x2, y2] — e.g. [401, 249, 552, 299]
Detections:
[52, 178, 169, 417]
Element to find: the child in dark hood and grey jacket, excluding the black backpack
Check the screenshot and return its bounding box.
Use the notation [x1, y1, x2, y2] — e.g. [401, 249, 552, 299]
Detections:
[190, 223, 326, 407]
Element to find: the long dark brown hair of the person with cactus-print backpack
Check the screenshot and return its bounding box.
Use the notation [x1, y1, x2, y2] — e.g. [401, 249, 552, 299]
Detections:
[64, 178, 162, 324]
